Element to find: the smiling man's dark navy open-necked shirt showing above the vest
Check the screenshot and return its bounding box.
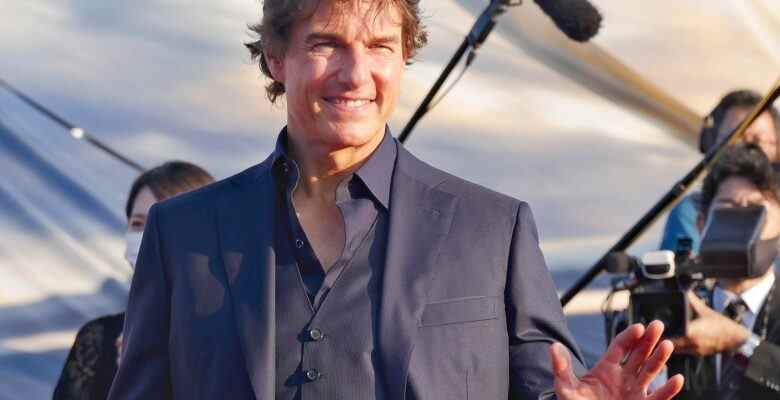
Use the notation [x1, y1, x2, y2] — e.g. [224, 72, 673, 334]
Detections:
[273, 128, 397, 310]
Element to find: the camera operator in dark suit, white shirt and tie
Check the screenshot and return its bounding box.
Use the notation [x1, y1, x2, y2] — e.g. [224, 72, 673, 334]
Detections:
[674, 144, 780, 399]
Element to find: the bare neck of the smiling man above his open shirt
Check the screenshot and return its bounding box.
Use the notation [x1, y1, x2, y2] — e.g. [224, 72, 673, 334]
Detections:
[288, 133, 384, 203]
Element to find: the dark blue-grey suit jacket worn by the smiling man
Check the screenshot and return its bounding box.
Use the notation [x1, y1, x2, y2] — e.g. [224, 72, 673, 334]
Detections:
[109, 138, 582, 400]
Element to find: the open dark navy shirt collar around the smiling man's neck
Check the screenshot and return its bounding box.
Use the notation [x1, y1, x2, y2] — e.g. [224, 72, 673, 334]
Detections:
[272, 127, 398, 210]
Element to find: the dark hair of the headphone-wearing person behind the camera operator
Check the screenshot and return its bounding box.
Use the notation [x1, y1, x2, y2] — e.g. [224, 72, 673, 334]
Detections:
[699, 89, 780, 154]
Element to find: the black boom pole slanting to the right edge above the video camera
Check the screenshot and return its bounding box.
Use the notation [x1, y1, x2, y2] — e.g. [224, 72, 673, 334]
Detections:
[561, 79, 780, 307]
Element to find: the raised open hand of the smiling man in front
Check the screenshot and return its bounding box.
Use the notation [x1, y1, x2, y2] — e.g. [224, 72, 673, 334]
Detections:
[550, 321, 683, 400]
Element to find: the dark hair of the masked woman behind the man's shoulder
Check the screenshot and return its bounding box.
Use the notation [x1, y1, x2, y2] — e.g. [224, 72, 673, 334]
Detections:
[125, 161, 214, 219]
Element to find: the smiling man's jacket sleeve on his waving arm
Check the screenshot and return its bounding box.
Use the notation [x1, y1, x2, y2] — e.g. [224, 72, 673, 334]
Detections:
[505, 203, 585, 400]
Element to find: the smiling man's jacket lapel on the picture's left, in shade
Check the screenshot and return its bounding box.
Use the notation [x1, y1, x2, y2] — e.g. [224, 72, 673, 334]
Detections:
[217, 160, 276, 400]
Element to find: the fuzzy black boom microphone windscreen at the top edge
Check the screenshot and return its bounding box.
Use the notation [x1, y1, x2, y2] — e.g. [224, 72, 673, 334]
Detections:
[534, 0, 602, 42]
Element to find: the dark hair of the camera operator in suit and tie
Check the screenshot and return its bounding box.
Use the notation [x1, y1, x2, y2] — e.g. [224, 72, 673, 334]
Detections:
[700, 143, 780, 214]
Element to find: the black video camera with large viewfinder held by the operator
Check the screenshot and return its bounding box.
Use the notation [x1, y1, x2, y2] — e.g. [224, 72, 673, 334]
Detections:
[604, 206, 766, 341]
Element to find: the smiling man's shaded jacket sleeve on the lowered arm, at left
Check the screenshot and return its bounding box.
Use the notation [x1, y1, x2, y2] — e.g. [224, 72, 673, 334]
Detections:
[108, 205, 172, 400]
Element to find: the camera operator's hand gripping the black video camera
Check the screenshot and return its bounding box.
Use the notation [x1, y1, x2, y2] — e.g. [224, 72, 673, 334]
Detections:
[671, 293, 750, 357]
